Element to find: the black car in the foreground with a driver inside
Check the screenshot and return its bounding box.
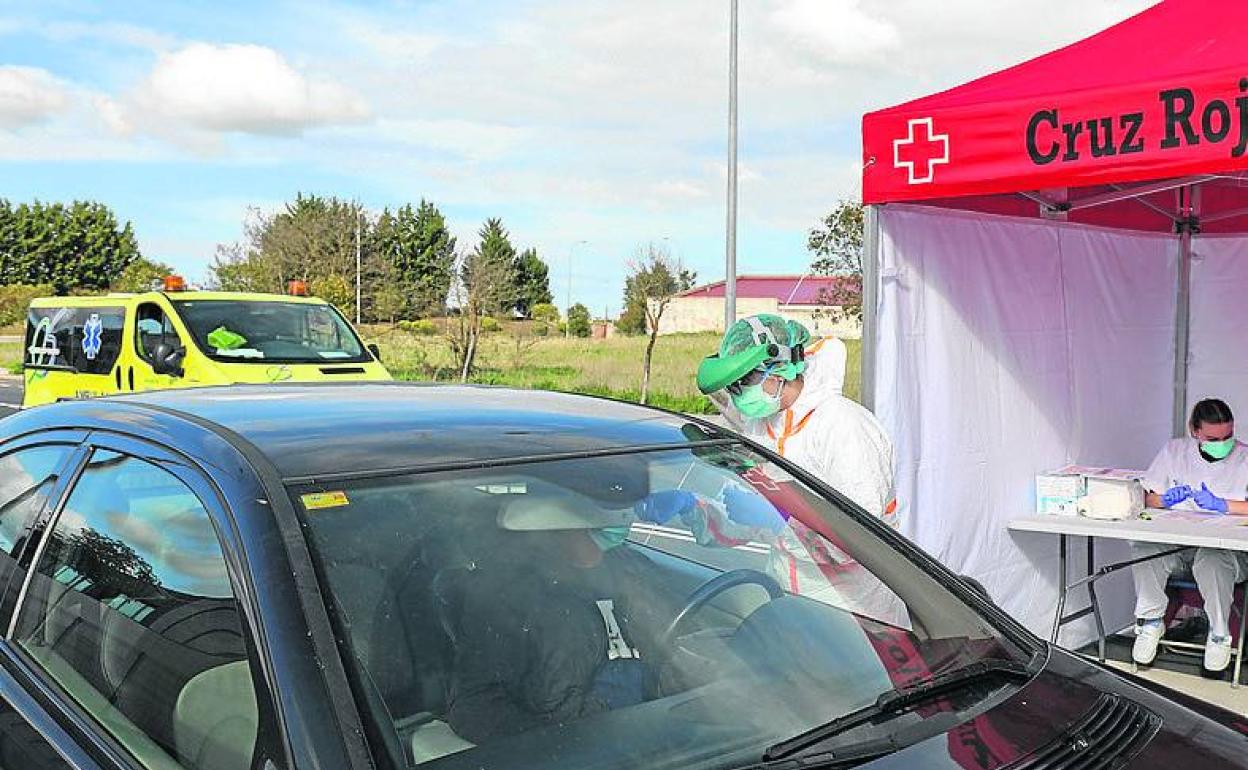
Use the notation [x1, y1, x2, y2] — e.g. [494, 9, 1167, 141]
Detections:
[0, 383, 1248, 770]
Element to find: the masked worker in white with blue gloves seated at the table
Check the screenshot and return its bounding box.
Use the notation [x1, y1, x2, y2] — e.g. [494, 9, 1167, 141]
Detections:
[1131, 398, 1248, 671]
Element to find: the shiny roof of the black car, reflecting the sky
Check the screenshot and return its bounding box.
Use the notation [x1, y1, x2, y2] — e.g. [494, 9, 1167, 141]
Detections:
[102, 382, 726, 480]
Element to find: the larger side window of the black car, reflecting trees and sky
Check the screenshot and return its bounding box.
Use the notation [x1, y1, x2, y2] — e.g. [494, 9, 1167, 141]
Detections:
[15, 449, 258, 770]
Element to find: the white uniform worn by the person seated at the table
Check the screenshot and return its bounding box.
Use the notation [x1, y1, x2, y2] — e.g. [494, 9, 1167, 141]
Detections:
[1131, 437, 1248, 636]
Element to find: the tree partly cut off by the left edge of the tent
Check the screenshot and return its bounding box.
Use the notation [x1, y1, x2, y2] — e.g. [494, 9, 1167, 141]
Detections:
[806, 200, 864, 321]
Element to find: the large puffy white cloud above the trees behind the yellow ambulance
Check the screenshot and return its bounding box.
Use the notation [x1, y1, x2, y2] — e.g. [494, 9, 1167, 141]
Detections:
[132, 42, 369, 135]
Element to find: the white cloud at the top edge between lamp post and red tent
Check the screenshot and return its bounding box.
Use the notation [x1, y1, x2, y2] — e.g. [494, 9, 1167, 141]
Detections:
[770, 0, 901, 64]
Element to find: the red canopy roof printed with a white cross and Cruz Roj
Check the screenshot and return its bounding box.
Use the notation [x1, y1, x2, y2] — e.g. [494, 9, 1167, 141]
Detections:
[862, 0, 1248, 232]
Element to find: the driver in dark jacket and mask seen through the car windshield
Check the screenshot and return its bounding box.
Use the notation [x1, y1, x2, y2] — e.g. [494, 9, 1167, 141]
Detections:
[448, 487, 683, 744]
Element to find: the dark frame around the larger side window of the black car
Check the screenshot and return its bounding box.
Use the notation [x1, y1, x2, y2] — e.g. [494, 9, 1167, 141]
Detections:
[0, 431, 291, 770]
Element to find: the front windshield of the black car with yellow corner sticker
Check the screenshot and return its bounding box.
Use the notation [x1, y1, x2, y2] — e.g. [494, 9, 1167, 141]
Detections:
[291, 444, 1027, 769]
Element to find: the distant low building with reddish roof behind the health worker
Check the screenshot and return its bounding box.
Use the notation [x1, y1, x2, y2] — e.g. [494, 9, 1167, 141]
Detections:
[659, 276, 862, 337]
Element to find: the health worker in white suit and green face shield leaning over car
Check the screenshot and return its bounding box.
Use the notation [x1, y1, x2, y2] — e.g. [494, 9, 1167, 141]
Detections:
[698, 314, 897, 527]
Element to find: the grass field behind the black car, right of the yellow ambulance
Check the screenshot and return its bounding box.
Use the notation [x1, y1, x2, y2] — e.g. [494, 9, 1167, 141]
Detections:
[0, 327, 860, 414]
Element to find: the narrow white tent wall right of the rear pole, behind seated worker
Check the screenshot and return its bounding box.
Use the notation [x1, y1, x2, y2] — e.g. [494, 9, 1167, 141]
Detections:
[1187, 236, 1248, 424]
